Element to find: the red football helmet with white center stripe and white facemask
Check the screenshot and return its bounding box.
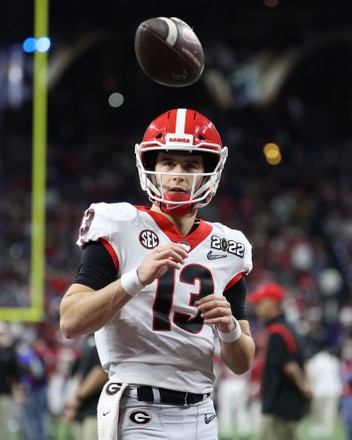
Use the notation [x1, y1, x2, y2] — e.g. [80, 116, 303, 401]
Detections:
[135, 108, 227, 216]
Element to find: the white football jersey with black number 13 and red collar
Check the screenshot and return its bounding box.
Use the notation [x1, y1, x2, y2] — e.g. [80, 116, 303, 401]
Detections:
[77, 203, 252, 393]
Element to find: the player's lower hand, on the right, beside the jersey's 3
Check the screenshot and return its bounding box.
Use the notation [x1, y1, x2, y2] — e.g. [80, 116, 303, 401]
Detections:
[195, 293, 235, 333]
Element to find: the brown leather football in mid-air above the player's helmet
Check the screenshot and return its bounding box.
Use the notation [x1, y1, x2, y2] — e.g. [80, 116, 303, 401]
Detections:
[135, 17, 204, 87]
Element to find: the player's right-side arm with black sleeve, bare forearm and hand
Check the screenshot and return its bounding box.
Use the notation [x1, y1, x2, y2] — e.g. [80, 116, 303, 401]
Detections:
[196, 278, 255, 374]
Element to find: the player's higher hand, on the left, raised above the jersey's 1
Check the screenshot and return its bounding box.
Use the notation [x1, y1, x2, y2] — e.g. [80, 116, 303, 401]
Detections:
[137, 243, 188, 286]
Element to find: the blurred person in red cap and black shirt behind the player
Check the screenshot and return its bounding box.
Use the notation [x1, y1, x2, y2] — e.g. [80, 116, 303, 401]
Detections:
[248, 282, 311, 440]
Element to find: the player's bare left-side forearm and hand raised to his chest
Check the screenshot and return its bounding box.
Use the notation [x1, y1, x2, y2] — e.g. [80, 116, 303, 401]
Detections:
[60, 243, 187, 339]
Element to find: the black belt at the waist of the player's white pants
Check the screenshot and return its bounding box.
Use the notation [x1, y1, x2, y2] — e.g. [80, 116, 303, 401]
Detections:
[137, 385, 210, 405]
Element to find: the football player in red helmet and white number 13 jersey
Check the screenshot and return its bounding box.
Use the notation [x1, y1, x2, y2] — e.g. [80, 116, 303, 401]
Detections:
[60, 108, 254, 440]
